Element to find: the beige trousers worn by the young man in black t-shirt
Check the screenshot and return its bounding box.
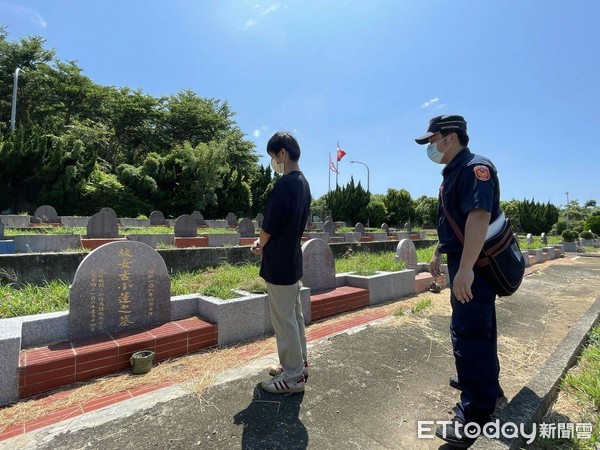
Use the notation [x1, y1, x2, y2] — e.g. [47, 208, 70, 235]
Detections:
[267, 283, 307, 380]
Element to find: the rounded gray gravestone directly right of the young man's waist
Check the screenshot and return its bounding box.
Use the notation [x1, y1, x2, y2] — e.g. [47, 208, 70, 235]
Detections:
[302, 239, 336, 293]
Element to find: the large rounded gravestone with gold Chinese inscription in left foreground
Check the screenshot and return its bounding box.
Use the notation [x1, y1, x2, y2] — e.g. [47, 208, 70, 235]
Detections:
[69, 243, 171, 339]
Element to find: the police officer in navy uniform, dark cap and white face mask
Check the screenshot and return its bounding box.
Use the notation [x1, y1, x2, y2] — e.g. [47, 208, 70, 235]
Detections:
[415, 115, 503, 447]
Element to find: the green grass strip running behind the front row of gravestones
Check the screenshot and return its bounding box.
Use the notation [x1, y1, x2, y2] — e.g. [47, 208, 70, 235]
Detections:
[0, 248, 435, 319]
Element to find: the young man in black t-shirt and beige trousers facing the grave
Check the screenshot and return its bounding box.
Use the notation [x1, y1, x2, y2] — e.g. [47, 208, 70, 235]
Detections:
[251, 131, 311, 393]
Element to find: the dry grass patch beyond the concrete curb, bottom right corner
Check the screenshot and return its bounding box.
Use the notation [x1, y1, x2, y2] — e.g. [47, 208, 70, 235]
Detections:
[534, 325, 600, 450]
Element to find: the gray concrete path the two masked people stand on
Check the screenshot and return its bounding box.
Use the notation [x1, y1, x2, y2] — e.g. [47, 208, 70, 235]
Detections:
[0, 255, 600, 449]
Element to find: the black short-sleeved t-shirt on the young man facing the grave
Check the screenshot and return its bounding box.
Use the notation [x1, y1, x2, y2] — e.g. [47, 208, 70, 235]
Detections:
[260, 172, 311, 285]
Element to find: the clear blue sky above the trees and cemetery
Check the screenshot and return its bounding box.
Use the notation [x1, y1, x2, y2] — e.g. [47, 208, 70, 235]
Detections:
[0, 0, 600, 206]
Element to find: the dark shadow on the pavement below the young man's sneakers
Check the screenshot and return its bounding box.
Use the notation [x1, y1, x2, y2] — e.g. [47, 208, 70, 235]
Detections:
[233, 384, 308, 450]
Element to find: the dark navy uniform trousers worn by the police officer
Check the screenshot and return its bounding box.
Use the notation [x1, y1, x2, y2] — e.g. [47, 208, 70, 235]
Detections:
[448, 255, 502, 425]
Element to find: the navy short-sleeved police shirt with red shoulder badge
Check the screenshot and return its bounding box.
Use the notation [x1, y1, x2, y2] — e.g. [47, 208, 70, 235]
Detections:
[437, 147, 500, 254]
